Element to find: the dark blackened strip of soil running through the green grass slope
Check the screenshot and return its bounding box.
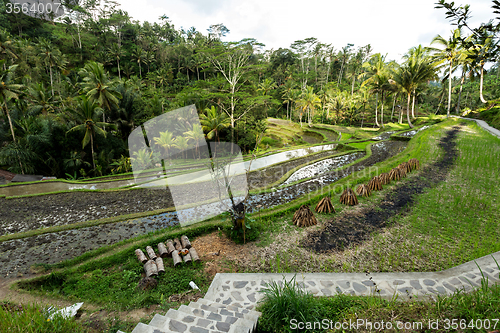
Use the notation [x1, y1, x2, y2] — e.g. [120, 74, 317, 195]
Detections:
[302, 126, 460, 252]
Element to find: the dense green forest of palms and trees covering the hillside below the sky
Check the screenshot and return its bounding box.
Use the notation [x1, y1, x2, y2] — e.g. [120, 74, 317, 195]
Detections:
[0, 0, 500, 178]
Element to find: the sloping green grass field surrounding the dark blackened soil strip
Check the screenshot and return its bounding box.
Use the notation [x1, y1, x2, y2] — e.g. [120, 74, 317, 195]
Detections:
[244, 119, 500, 272]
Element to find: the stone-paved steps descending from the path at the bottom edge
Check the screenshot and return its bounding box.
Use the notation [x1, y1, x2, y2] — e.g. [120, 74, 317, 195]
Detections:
[117, 298, 261, 333]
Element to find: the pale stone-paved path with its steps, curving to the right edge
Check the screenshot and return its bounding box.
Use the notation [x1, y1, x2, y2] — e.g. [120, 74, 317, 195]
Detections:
[122, 251, 500, 333]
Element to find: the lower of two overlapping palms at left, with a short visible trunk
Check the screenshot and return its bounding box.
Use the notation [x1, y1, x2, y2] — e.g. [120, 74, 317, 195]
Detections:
[66, 96, 113, 169]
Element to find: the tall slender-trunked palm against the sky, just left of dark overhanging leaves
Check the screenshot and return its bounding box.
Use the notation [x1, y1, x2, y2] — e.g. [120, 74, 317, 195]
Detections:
[430, 29, 462, 117]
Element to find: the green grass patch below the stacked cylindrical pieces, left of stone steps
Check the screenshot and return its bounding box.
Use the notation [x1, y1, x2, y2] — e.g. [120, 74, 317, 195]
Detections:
[21, 256, 211, 310]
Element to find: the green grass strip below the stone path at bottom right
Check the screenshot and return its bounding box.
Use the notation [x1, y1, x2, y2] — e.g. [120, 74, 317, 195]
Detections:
[258, 266, 500, 332]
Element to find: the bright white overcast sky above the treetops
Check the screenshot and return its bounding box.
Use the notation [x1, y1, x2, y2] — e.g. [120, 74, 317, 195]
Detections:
[118, 0, 494, 61]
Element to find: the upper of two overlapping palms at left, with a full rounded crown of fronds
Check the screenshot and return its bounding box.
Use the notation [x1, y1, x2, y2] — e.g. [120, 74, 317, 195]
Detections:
[79, 61, 122, 123]
